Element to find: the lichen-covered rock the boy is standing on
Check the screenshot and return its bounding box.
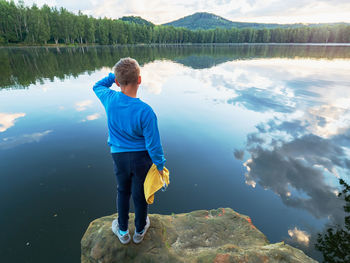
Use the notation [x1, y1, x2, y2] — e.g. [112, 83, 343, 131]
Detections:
[81, 208, 317, 263]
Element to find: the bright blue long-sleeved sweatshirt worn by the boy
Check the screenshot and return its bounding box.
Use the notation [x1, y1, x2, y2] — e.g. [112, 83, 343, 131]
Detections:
[93, 73, 165, 170]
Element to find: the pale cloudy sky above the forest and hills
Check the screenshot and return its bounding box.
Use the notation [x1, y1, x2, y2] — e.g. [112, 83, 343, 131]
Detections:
[17, 0, 350, 24]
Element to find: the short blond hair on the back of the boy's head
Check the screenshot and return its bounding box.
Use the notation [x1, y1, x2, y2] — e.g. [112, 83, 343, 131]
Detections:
[114, 57, 140, 86]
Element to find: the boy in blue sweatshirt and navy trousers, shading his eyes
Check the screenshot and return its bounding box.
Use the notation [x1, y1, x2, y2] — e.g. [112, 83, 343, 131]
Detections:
[93, 58, 165, 244]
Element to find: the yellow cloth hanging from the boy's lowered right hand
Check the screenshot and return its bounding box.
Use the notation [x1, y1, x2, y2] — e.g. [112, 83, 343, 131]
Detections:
[143, 164, 170, 204]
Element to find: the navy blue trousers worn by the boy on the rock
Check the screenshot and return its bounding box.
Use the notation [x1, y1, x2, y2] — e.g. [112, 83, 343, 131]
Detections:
[112, 151, 152, 232]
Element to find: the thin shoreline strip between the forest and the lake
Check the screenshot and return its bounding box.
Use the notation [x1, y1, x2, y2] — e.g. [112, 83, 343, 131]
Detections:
[0, 42, 350, 48]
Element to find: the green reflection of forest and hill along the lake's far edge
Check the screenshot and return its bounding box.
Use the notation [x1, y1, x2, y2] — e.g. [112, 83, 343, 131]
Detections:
[0, 45, 350, 89]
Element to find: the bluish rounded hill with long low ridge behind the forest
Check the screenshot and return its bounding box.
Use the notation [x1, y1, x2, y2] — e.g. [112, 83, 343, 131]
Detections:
[163, 12, 338, 30]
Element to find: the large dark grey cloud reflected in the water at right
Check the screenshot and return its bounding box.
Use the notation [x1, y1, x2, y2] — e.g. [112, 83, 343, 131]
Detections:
[241, 135, 348, 221]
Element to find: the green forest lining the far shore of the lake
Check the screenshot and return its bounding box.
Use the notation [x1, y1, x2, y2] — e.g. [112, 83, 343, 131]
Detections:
[0, 0, 350, 45]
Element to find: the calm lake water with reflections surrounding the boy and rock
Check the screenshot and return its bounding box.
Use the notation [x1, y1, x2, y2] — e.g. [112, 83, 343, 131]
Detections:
[0, 45, 350, 263]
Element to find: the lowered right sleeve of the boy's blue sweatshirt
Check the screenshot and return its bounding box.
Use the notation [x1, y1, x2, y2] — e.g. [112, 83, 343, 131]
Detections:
[142, 110, 166, 170]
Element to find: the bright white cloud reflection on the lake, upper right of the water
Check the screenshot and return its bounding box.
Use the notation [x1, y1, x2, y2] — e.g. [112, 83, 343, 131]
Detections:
[198, 58, 350, 138]
